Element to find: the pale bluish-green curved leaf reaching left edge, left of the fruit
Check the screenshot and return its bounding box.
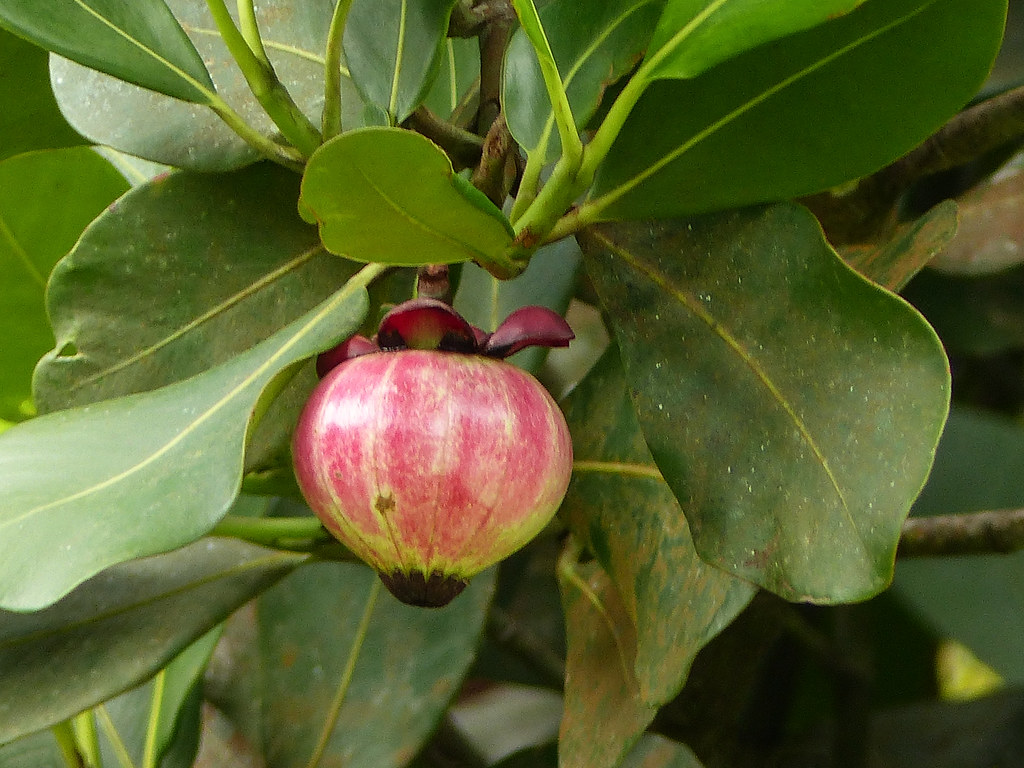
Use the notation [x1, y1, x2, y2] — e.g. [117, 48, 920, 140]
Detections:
[0, 284, 367, 610]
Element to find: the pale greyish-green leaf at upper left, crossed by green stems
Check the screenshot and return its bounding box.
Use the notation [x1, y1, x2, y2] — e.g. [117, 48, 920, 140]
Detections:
[50, 0, 348, 171]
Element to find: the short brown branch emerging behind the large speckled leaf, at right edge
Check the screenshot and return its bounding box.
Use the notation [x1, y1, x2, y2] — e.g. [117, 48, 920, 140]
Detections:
[897, 509, 1024, 557]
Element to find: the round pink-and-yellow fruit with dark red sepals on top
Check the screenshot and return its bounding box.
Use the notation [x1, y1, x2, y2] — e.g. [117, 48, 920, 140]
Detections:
[293, 299, 572, 606]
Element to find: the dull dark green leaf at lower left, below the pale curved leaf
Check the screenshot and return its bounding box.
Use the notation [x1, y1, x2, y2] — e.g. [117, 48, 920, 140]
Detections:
[0, 539, 304, 742]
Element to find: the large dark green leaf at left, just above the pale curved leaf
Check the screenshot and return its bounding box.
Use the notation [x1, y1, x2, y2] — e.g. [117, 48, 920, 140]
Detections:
[34, 164, 356, 412]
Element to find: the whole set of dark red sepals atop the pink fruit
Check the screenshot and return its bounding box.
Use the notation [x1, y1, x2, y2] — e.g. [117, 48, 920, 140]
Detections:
[316, 299, 575, 378]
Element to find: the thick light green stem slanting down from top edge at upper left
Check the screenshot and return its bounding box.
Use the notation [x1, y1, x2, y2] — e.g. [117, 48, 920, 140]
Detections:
[206, 0, 322, 158]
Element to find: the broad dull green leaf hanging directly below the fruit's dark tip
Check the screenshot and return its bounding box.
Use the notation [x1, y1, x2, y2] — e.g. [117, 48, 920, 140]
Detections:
[249, 563, 495, 768]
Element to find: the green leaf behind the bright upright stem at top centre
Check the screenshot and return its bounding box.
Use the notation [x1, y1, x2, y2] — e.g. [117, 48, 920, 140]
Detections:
[502, 0, 665, 160]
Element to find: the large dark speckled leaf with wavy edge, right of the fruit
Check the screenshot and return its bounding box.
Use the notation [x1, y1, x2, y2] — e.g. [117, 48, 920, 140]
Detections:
[584, 205, 949, 602]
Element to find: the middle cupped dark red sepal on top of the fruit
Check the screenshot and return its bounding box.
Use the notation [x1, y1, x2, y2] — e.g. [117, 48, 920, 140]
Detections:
[377, 299, 478, 353]
